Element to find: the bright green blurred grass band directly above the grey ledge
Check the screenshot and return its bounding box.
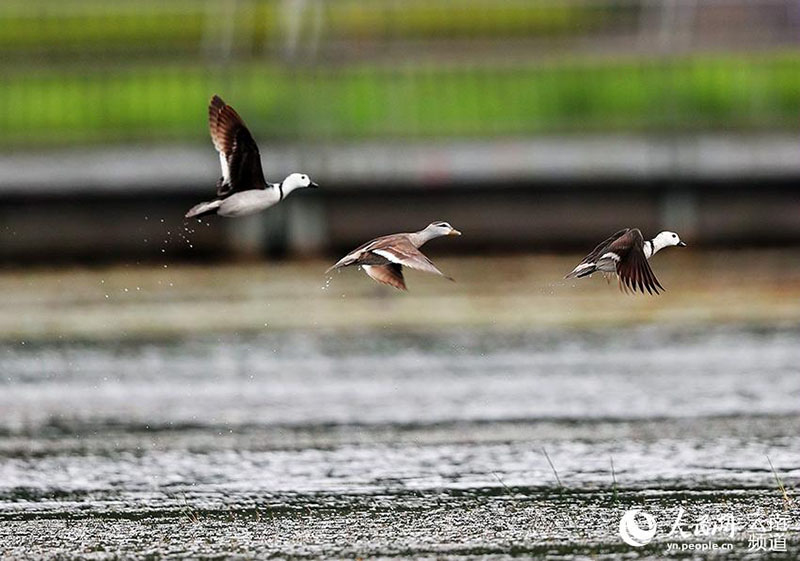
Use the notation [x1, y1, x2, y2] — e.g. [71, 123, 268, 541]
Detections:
[0, 53, 800, 146]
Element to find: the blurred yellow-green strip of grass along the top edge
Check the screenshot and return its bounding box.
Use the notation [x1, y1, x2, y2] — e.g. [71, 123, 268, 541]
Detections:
[0, 0, 641, 52]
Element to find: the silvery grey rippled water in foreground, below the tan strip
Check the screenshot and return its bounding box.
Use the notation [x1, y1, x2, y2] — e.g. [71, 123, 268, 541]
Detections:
[0, 327, 800, 558]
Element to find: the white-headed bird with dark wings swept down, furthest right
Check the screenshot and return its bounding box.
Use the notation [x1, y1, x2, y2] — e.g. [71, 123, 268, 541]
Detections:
[564, 228, 686, 294]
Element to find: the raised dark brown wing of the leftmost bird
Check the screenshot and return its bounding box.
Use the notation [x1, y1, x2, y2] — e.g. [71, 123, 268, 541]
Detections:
[208, 95, 267, 197]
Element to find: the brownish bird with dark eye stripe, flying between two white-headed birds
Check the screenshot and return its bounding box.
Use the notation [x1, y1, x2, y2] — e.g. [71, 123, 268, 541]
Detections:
[325, 222, 461, 290]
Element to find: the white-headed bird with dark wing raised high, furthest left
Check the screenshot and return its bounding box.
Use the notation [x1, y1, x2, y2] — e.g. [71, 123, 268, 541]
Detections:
[185, 95, 317, 218]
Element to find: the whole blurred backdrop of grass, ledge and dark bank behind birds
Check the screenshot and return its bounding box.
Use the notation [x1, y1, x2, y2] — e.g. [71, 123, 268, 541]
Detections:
[0, 0, 800, 264]
